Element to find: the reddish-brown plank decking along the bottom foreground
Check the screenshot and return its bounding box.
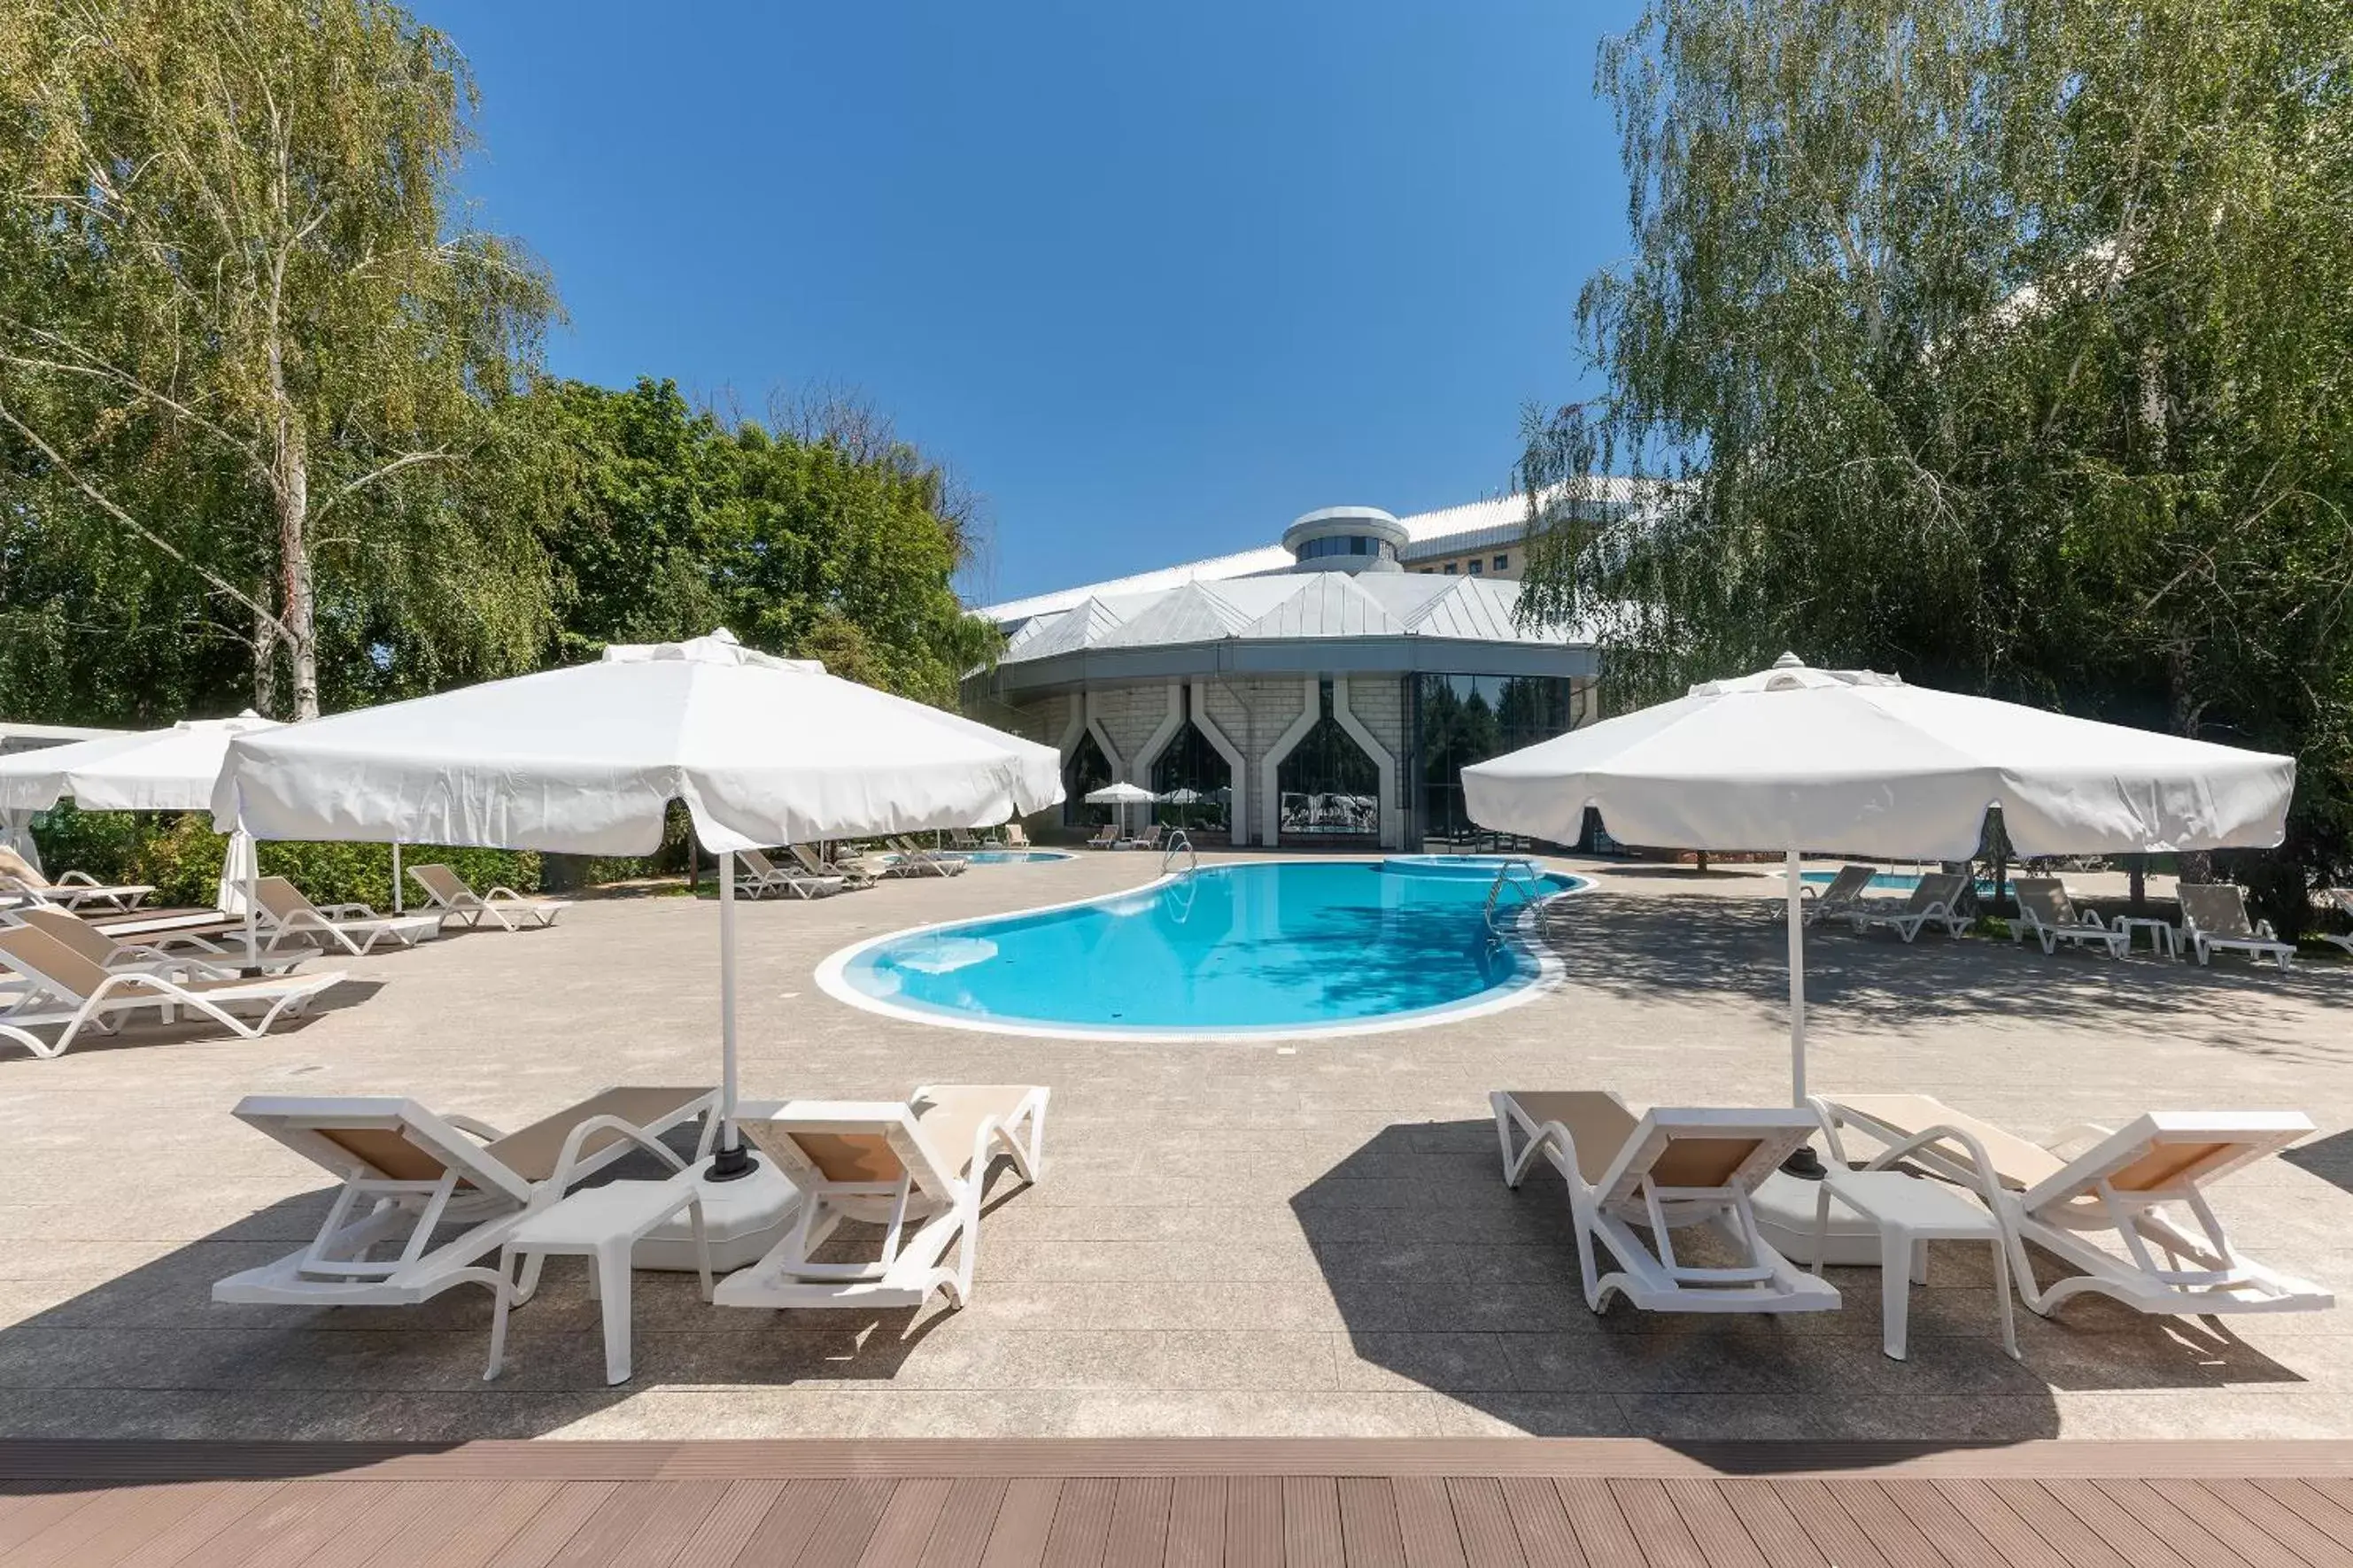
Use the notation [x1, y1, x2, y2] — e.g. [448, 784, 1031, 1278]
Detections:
[0, 1443, 2353, 1568]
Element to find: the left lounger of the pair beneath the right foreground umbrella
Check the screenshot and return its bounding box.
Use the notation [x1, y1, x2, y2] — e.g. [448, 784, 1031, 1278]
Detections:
[1490, 1091, 1838, 1312]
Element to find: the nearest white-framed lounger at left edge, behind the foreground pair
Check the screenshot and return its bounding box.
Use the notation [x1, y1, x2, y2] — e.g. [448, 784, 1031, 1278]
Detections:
[0, 926, 344, 1058]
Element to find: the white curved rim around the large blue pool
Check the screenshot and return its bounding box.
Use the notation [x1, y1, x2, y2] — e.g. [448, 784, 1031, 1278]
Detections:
[817, 855, 1593, 1047]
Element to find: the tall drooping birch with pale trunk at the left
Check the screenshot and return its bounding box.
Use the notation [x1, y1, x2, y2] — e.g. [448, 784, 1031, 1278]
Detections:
[0, 0, 553, 717]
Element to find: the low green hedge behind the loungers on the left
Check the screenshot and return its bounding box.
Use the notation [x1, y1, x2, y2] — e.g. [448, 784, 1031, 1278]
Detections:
[33, 801, 538, 910]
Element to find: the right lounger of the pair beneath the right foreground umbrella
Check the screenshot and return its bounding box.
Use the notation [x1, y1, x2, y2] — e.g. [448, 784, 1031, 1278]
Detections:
[1816, 1095, 2334, 1317]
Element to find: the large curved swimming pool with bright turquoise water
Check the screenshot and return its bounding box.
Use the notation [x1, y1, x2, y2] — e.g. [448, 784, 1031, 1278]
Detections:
[817, 855, 1586, 1039]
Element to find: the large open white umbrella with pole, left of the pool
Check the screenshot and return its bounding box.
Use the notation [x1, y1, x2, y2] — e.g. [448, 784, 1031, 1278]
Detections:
[212, 630, 1061, 1173]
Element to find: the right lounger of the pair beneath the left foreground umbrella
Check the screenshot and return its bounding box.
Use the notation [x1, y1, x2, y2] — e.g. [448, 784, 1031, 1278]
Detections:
[713, 1084, 1047, 1307]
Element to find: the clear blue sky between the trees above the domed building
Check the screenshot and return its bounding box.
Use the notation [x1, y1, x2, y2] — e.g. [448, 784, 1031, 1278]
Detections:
[414, 0, 1633, 599]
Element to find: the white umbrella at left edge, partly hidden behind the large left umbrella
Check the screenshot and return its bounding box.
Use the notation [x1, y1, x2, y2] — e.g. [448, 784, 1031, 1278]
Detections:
[0, 710, 280, 912]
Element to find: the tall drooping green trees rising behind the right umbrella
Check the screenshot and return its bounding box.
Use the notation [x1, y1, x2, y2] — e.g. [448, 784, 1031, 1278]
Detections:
[1522, 0, 2353, 922]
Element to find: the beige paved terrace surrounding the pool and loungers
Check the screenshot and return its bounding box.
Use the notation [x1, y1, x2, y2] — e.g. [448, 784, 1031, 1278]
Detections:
[0, 854, 2353, 1443]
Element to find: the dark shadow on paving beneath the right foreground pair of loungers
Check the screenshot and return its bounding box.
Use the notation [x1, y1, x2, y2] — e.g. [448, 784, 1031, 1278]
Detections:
[1292, 1122, 2302, 1443]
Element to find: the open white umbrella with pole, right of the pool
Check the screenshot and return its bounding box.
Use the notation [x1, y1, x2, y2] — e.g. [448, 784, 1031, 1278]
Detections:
[1464, 653, 2296, 1105]
